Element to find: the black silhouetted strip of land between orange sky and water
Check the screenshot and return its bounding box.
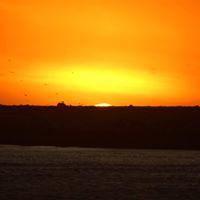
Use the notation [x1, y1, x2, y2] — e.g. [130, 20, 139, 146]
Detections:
[0, 106, 200, 149]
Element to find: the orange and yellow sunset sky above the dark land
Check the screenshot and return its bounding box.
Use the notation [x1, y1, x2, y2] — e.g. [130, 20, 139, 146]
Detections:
[0, 0, 200, 105]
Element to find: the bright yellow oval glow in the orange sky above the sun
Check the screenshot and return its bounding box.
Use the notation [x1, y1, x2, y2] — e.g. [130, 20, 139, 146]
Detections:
[37, 64, 169, 95]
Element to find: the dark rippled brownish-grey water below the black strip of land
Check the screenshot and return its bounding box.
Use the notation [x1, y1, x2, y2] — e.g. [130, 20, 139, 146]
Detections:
[0, 146, 200, 200]
